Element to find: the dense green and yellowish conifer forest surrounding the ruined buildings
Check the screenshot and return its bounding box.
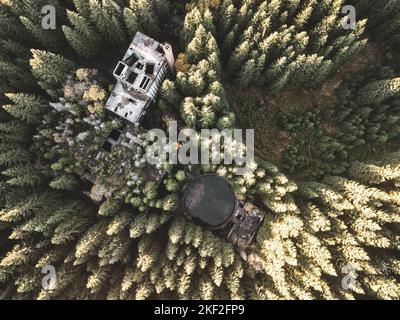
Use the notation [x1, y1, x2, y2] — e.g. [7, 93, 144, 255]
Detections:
[0, 0, 400, 299]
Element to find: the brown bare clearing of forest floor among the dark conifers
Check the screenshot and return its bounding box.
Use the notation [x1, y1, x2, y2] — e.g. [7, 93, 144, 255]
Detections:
[227, 43, 380, 170]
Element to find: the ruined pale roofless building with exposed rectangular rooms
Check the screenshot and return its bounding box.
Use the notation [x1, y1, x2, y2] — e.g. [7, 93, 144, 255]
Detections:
[106, 32, 174, 124]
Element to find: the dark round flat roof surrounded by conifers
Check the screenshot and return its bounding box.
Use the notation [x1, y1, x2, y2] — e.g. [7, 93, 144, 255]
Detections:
[183, 174, 237, 229]
